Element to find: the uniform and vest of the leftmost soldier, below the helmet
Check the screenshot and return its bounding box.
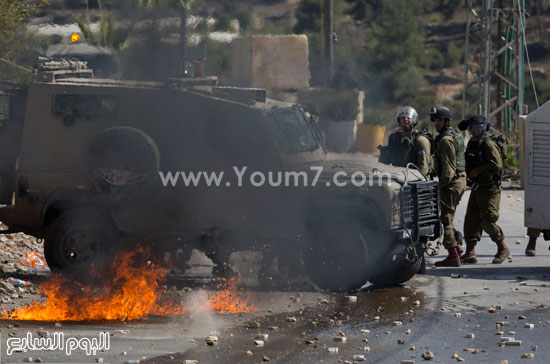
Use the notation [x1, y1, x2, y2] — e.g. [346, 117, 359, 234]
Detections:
[380, 130, 432, 175]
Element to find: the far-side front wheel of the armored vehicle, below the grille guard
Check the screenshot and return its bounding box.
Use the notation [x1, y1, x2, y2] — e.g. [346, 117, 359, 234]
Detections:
[370, 243, 424, 287]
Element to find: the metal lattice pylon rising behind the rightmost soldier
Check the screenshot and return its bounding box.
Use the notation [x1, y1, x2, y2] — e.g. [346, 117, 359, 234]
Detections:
[462, 0, 525, 131]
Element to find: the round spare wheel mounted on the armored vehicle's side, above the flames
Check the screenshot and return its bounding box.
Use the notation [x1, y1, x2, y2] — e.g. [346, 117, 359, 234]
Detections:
[87, 127, 160, 201]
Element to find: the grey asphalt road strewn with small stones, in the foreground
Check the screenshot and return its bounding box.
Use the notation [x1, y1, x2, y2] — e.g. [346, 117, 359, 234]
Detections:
[0, 191, 550, 364]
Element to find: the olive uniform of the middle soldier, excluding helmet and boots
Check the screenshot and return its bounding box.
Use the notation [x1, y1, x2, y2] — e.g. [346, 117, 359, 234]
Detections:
[434, 127, 466, 249]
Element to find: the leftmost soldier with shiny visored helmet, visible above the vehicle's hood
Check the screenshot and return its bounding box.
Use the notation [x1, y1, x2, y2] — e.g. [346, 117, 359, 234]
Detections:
[379, 106, 431, 175]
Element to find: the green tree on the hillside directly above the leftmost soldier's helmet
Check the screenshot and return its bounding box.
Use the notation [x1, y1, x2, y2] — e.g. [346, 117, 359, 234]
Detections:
[363, 0, 426, 101]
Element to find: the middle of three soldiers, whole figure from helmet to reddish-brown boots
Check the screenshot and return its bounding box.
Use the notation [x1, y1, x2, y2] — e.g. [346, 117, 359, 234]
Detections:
[430, 106, 466, 267]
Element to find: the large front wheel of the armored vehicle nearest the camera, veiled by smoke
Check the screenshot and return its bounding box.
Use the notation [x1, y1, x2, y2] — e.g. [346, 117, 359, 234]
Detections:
[303, 207, 379, 292]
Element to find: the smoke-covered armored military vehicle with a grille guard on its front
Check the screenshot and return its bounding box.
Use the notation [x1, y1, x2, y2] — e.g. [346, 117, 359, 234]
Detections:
[0, 61, 439, 290]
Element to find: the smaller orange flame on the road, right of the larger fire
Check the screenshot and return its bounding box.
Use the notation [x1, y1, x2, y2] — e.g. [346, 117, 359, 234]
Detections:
[208, 277, 259, 313]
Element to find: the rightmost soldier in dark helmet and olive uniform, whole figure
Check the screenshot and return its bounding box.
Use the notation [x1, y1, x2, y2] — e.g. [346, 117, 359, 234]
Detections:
[459, 115, 510, 264]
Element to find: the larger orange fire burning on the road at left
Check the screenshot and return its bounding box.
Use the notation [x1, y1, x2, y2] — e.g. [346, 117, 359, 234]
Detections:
[0, 248, 185, 321]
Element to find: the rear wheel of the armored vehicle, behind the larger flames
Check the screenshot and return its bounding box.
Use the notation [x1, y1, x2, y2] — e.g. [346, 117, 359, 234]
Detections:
[44, 209, 119, 275]
